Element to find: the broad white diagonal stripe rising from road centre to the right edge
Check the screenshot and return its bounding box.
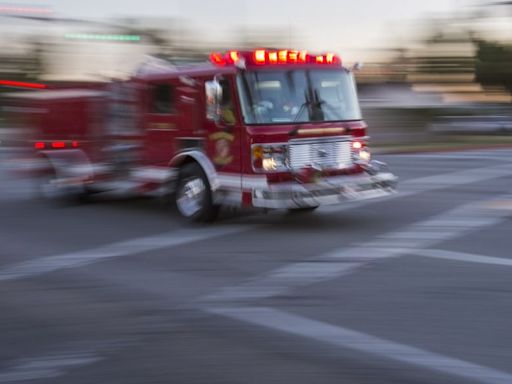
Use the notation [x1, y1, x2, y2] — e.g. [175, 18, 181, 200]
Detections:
[206, 196, 509, 302]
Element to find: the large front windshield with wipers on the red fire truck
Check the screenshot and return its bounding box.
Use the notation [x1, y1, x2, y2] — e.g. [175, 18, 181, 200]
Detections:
[238, 69, 361, 124]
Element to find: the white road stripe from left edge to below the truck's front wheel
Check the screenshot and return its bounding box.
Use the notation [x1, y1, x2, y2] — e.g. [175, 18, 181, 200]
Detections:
[0, 226, 254, 282]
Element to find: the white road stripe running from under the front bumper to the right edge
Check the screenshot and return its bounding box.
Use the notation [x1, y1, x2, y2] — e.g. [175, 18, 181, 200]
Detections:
[320, 164, 512, 213]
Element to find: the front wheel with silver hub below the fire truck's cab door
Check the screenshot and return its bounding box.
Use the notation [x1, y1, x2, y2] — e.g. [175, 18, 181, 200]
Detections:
[176, 163, 219, 223]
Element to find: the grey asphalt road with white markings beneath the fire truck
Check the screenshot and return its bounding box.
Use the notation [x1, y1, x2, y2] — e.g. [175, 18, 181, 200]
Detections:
[0, 150, 512, 384]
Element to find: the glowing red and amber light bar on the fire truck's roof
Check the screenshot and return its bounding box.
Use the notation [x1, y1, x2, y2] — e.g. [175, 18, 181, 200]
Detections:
[210, 49, 341, 67]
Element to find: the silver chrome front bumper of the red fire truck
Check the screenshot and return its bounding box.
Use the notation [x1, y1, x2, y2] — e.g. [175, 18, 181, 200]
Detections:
[252, 168, 398, 209]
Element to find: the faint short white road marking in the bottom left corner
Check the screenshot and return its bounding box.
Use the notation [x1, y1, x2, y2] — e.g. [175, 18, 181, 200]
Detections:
[0, 351, 103, 384]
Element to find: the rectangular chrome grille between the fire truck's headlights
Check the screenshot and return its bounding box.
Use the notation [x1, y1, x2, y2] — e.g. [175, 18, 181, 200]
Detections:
[288, 137, 352, 169]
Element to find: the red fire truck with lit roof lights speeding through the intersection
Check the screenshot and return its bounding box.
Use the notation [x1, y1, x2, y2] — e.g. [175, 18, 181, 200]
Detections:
[14, 49, 397, 222]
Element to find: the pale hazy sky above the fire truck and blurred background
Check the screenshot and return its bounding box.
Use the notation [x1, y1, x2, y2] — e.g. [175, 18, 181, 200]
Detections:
[6, 0, 476, 60]
